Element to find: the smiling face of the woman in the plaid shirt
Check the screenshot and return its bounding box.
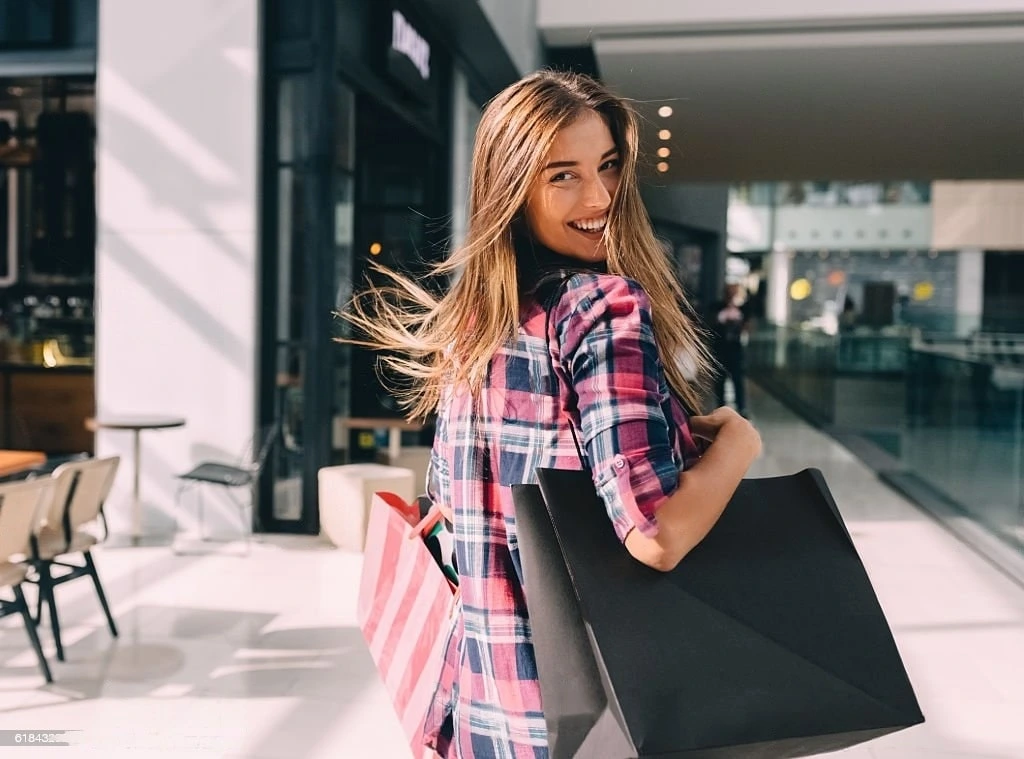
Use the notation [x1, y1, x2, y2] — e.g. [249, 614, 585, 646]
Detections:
[526, 111, 620, 261]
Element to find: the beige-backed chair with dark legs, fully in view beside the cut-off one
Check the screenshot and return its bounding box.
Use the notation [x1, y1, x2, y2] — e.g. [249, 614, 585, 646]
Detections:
[29, 456, 121, 662]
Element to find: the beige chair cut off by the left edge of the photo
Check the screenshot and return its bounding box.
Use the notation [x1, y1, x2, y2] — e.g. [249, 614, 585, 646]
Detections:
[0, 479, 53, 682]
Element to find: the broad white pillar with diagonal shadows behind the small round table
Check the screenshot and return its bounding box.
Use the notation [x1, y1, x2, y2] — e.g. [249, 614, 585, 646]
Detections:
[96, 0, 259, 533]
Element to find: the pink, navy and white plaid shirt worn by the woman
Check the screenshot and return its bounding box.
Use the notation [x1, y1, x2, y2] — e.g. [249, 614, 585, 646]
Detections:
[426, 272, 698, 759]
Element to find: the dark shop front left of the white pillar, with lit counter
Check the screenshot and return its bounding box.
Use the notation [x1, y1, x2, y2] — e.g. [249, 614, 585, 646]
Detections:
[0, 0, 96, 456]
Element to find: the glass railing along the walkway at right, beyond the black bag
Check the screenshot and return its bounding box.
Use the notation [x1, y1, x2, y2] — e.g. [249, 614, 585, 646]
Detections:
[748, 325, 1024, 550]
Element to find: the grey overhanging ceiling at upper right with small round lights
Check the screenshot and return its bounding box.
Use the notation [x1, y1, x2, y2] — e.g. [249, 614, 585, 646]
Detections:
[569, 24, 1024, 181]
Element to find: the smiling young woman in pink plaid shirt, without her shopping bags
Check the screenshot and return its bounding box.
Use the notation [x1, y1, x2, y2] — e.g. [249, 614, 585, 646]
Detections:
[348, 72, 761, 759]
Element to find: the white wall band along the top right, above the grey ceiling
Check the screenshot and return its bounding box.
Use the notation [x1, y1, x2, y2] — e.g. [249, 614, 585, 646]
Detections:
[540, 0, 1024, 44]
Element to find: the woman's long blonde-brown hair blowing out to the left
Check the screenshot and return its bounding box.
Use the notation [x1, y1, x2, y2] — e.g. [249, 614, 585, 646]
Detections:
[341, 71, 711, 418]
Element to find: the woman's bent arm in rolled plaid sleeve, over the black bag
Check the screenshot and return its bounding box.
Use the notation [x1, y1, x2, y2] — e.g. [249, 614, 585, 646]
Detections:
[553, 275, 761, 571]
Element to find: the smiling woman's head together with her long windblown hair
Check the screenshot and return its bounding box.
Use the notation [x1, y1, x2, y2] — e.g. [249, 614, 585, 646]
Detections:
[343, 72, 709, 418]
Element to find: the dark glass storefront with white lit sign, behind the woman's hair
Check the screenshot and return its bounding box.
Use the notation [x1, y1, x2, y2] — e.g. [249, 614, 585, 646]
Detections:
[258, 0, 517, 532]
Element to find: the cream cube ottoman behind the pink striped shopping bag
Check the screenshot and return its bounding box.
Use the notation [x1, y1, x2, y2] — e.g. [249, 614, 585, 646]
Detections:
[317, 464, 416, 551]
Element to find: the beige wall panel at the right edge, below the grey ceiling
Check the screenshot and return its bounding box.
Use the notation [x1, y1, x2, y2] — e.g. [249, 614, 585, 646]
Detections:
[932, 181, 1024, 250]
